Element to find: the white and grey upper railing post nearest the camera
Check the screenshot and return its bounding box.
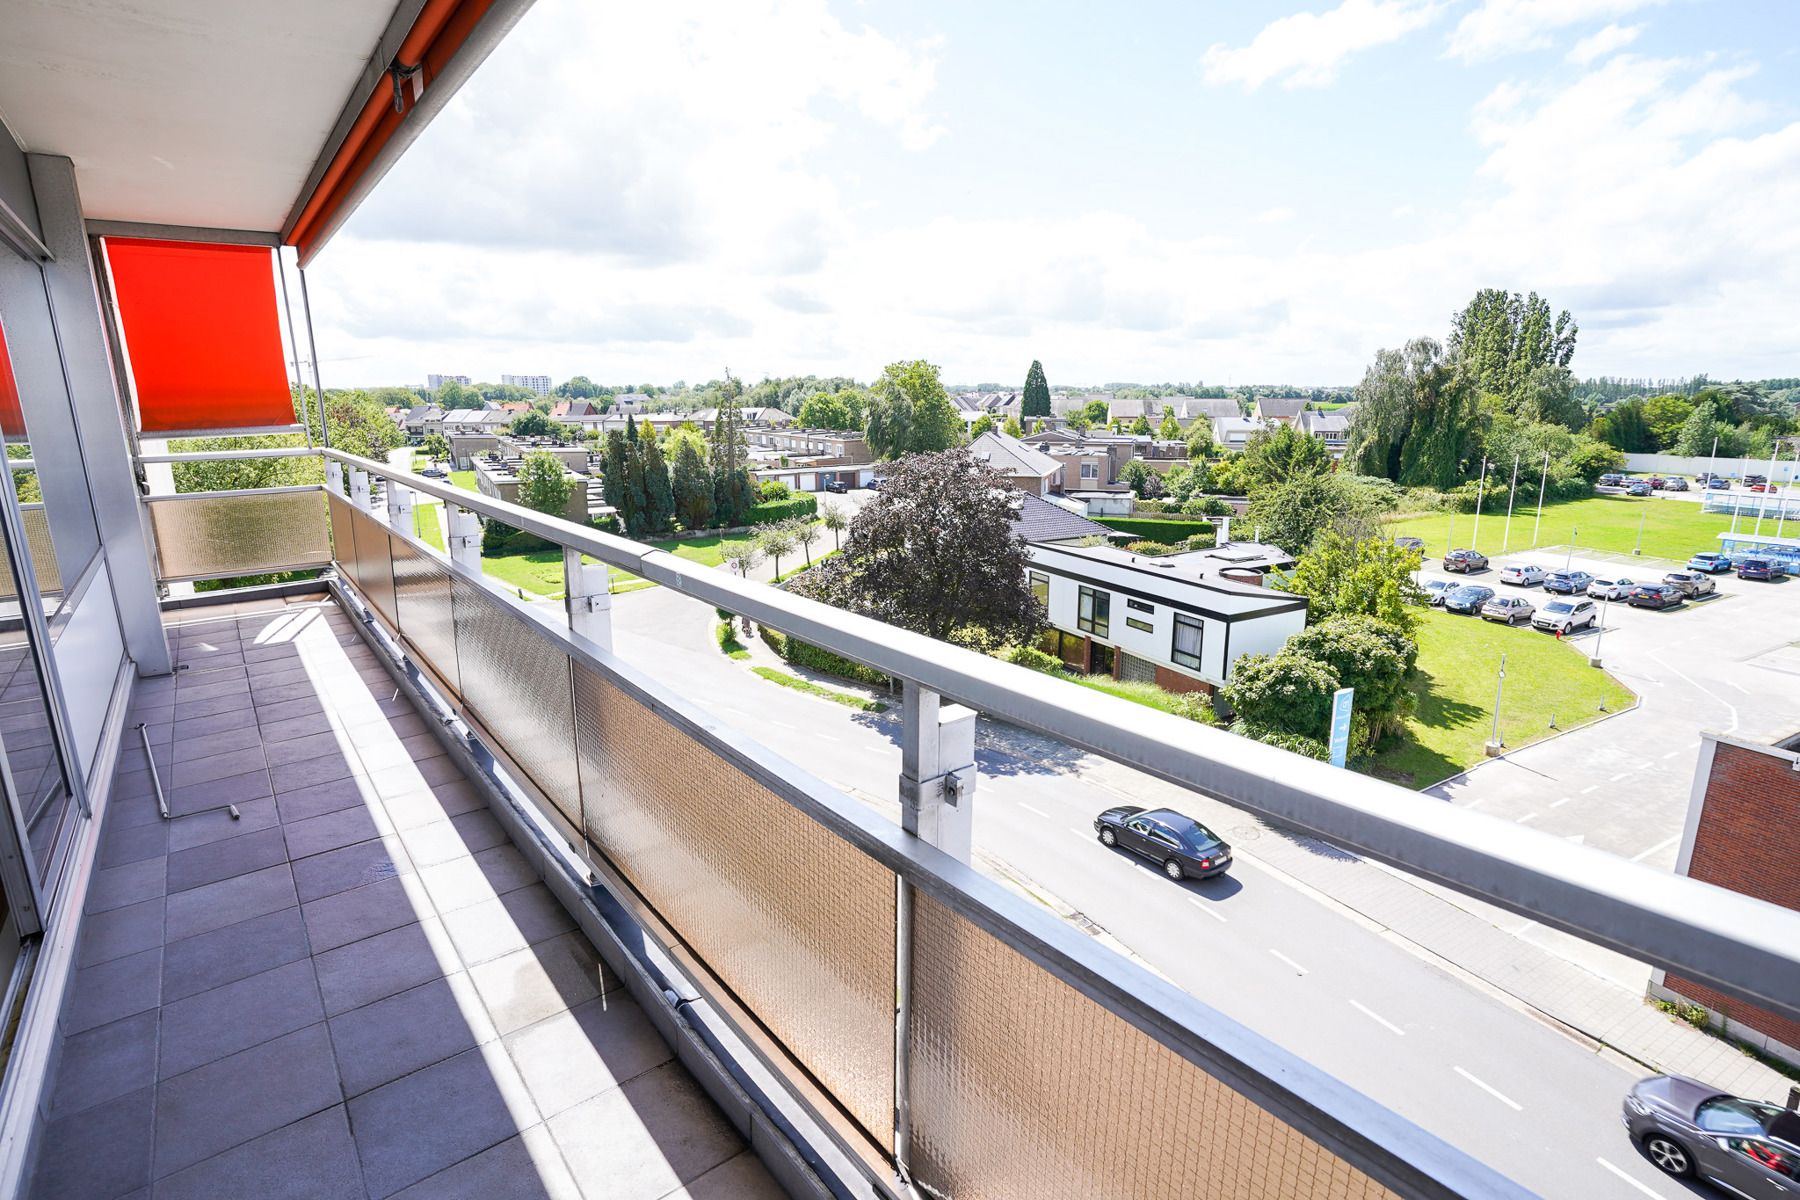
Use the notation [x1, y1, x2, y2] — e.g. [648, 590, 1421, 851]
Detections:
[900, 682, 976, 862]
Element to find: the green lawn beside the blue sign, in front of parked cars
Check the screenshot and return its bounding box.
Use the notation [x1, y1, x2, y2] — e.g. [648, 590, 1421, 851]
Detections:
[1366, 611, 1631, 788]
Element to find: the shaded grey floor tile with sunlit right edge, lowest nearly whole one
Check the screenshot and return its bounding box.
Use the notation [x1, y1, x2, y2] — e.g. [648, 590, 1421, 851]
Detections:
[349, 1042, 538, 1196]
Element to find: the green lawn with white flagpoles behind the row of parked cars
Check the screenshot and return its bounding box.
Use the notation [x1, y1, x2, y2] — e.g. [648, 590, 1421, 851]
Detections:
[1382, 484, 1732, 565]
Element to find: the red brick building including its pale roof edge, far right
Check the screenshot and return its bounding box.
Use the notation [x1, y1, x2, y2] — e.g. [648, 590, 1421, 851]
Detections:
[1651, 734, 1800, 1065]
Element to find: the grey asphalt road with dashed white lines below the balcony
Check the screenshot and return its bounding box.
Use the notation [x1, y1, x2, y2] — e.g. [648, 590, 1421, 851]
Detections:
[614, 588, 1701, 1200]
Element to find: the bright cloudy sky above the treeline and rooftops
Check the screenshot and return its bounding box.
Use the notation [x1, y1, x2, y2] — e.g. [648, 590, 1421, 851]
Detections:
[308, 0, 1800, 387]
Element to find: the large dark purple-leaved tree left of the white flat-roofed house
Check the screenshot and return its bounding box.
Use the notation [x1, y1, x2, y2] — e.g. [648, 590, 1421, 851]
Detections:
[796, 448, 1044, 648]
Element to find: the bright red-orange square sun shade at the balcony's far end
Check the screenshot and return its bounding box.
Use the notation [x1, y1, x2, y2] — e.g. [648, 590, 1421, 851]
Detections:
[106, 237, 293, 434]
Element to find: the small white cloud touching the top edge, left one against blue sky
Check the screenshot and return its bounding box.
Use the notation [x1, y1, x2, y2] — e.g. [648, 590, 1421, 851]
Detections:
[1201, 0, 1440, 92]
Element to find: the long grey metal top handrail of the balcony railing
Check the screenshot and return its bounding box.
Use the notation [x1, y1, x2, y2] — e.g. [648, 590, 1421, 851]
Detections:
[322, 450, 1800, 1018]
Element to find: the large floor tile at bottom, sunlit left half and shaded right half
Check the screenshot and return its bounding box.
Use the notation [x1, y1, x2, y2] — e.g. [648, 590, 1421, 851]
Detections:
[549, 1063, 743, 1200]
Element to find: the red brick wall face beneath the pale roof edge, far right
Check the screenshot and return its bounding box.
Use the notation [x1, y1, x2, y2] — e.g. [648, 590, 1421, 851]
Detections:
[1663, 741, 1800, 1049]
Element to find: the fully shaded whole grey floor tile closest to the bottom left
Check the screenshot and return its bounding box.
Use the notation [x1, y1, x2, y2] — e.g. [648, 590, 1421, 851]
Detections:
[155, 1024, 342, 1177]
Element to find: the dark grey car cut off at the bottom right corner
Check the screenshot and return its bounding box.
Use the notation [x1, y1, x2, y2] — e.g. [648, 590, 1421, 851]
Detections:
[1622, 1076, 1800, 1196]
